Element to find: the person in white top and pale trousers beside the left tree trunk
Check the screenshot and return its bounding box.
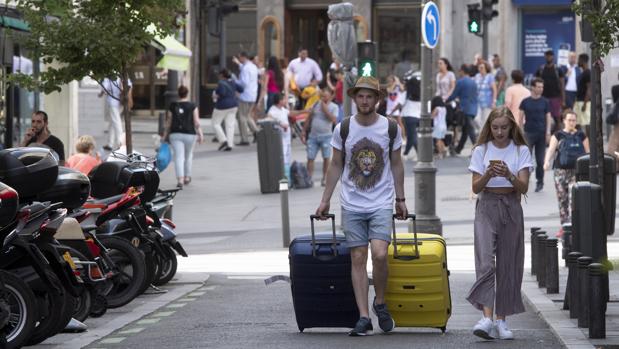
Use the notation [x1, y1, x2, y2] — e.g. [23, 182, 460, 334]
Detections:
[99, 77, 133, 151]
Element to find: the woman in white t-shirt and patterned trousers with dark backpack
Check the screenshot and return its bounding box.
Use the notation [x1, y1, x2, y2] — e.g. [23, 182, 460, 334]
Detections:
[544, 109, 589, 237]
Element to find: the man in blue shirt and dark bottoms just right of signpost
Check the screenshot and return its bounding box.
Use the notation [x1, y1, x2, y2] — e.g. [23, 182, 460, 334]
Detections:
[446, 64, 477, 154]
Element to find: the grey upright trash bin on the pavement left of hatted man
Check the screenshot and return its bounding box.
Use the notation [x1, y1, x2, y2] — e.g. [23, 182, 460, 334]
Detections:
[256, 120, 284, 194]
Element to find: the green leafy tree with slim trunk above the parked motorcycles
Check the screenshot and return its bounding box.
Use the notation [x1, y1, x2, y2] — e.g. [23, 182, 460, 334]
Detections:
[11, 0, 185, 153]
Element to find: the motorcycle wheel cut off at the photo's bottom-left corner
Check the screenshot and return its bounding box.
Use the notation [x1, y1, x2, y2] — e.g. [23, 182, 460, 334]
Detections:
[0, 270, 39, 349]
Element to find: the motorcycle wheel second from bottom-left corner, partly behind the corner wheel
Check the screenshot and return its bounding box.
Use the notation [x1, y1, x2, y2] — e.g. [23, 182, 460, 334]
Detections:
[26, 270, 75, 345]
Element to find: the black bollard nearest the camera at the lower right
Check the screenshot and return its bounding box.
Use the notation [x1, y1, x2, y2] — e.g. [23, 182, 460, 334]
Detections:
[589, 263, 606, 338]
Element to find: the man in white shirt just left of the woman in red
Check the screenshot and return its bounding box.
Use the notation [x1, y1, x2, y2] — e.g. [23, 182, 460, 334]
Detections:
[233, 52, 258, 146]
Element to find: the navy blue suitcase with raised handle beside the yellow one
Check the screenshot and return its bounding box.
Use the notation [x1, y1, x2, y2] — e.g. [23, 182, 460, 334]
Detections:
[288, 214, 359, 332]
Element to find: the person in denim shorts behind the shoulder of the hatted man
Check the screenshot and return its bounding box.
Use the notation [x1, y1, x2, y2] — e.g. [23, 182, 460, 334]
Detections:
[301, 87, 338, 187]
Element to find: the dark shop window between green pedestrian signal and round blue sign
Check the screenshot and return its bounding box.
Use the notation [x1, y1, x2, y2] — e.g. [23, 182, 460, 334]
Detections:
[373, 7, 421, 81]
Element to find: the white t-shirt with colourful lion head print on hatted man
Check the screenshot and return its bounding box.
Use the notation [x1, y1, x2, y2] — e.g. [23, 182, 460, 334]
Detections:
[331, 116, 402, 213]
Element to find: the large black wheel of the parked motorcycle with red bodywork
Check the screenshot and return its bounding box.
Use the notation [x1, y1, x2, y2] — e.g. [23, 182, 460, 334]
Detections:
[100, 236, 146, 308]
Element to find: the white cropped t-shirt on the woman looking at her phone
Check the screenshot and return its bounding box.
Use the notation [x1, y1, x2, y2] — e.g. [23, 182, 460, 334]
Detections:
[469, 141, 533, 188]
